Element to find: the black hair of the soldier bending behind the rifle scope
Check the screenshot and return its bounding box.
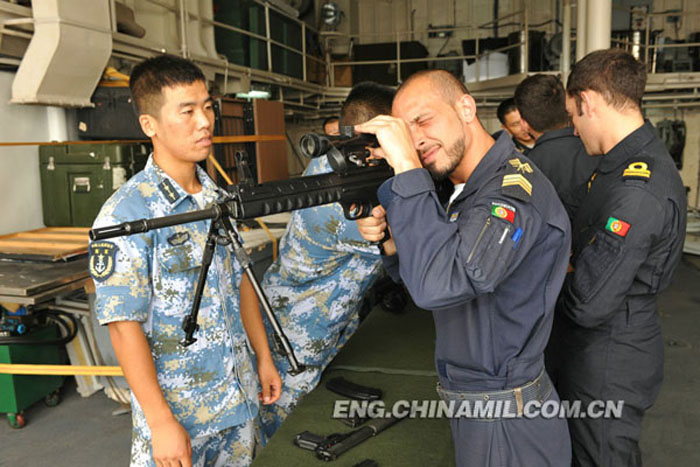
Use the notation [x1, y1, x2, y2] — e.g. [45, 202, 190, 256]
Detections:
[340, 81, 396, 126]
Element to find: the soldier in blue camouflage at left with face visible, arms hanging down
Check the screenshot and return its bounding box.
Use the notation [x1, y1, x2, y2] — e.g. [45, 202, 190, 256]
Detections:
[89, 56, 281, 466]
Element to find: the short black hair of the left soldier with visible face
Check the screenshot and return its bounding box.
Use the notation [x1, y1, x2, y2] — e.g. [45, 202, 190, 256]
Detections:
[129, 55, 206, 117]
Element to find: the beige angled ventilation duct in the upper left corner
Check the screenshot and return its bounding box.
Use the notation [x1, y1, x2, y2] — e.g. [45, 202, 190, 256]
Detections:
[11, 0, 112, 107]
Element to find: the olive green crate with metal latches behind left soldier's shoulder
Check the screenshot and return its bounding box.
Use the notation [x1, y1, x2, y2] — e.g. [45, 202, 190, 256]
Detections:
[39, 143, 149, 227]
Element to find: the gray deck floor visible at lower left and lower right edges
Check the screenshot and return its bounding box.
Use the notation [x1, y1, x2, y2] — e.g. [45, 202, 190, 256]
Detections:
[0, 256, 700, 467]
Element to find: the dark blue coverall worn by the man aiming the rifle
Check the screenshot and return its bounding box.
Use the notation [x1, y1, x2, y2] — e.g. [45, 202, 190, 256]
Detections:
[378, 134, 571, 467]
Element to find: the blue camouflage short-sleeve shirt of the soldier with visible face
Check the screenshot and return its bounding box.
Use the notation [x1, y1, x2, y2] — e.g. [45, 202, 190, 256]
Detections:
[89, 156, 257, 437]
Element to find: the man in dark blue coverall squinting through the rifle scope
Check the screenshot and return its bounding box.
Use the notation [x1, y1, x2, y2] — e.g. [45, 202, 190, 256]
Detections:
[355, 71, 571, 466]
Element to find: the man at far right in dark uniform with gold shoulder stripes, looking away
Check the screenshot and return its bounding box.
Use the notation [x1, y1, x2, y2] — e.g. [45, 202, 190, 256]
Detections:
[557, 49, 686, 466]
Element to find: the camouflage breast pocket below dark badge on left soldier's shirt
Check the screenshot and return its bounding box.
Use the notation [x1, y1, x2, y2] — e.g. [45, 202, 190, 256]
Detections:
[154, 244, 202, 316]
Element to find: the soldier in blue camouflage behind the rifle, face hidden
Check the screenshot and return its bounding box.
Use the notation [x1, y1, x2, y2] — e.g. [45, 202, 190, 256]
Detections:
[261, 82, 394, 437]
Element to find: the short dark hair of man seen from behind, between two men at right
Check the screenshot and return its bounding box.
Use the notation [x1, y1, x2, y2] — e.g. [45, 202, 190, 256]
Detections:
[515, 73, 569, 133]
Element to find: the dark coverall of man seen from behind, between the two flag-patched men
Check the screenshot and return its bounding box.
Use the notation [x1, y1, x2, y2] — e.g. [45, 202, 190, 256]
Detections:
[527, 127, 601, 221]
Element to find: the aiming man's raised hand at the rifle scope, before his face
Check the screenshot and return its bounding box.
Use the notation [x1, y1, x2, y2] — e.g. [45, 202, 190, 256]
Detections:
[355, 115, 423, 174]
